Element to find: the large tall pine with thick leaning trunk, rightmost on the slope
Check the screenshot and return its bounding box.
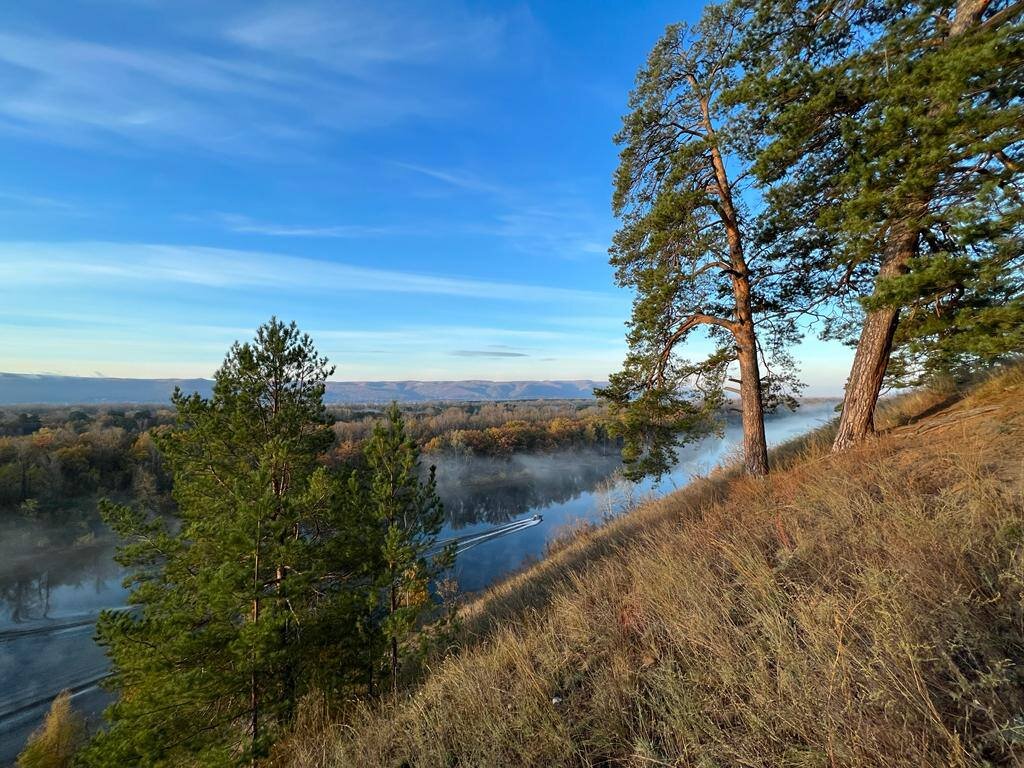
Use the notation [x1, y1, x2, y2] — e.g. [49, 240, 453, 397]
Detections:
[731, 0, 1024, 450]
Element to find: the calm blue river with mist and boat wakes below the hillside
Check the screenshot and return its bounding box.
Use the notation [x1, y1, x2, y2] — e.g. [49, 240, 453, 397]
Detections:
[0, 400, 836, 765]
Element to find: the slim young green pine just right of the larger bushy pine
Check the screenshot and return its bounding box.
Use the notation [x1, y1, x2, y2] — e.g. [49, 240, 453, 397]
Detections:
[352, 403, 455, 693]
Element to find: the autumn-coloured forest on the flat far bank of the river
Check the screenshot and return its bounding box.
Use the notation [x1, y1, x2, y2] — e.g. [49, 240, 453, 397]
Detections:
[0, 400, 617, 524]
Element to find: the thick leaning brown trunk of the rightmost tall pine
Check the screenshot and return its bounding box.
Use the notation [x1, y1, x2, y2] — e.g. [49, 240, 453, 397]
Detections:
[833, 227, 920, 452]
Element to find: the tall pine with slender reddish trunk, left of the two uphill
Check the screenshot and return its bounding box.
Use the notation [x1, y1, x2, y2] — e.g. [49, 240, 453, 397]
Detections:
[598, 6, 796, 477]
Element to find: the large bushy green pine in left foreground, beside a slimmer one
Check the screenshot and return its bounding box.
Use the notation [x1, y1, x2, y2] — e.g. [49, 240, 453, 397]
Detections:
[85, 319, 366, 766]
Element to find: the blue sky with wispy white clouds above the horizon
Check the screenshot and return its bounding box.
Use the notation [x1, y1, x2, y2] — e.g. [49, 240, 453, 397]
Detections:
[0, 0, 849, 393]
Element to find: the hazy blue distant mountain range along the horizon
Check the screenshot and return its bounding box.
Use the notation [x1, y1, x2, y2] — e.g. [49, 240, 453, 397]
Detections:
[0, 373, 602, 406]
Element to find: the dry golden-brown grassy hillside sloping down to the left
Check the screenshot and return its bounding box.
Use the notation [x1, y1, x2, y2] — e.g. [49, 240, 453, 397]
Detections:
[281, 369, 1024, 767]
